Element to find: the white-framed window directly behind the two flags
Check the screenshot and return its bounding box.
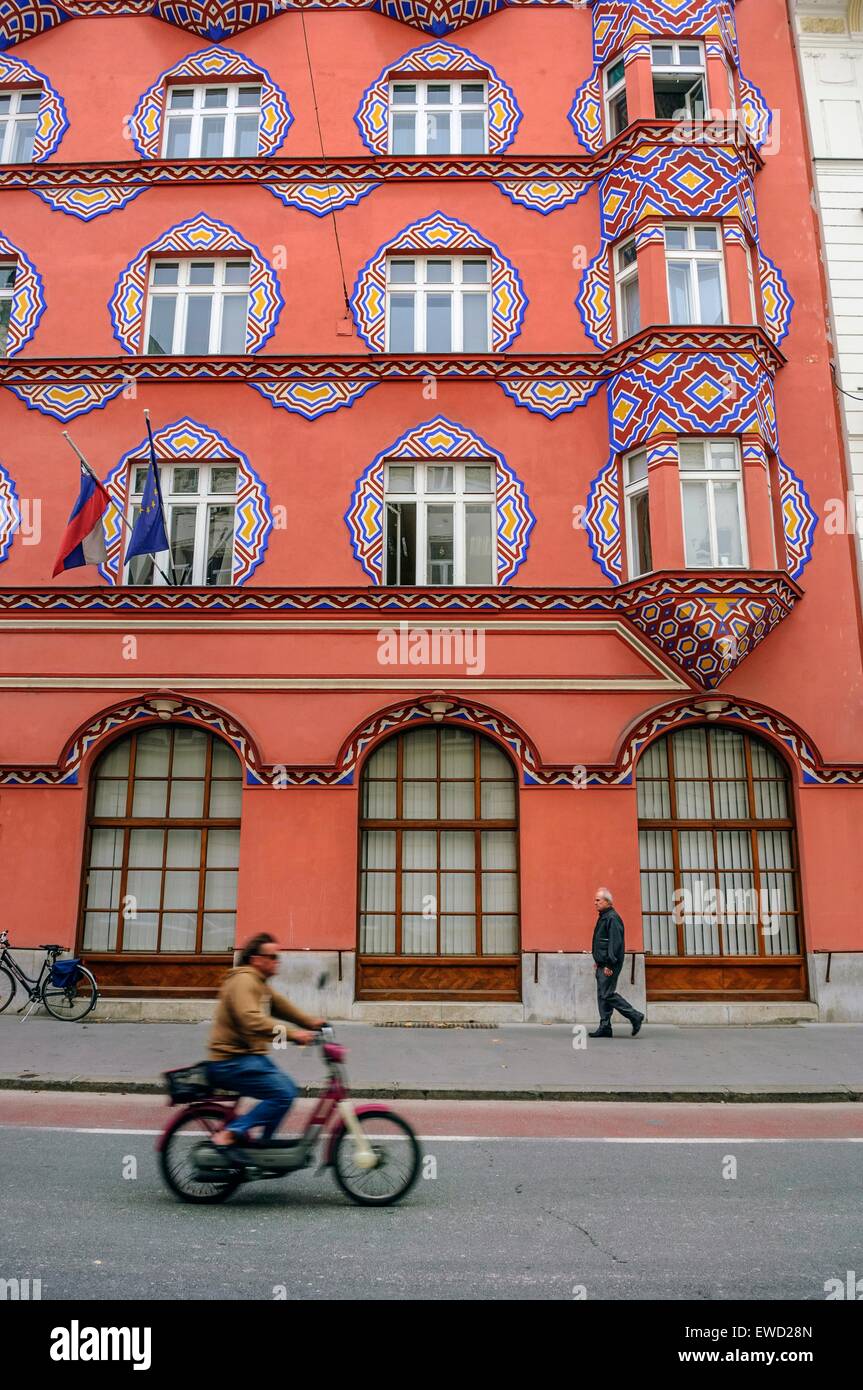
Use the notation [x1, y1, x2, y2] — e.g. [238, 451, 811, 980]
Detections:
[125, 463, 236, 585]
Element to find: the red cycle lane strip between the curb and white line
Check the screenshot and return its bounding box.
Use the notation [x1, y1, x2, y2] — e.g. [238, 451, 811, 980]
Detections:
[0, 1091, 863, 1147]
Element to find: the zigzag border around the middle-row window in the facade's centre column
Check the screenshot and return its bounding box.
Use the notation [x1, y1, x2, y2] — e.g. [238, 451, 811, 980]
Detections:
[350, 213, 527, 352]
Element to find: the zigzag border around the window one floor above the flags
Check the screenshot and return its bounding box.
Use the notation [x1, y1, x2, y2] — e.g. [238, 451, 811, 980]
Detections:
[108, 213, 285, 353]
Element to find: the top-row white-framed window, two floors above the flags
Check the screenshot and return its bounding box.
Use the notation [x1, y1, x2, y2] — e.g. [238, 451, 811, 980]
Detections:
[163, 85, 261, 160]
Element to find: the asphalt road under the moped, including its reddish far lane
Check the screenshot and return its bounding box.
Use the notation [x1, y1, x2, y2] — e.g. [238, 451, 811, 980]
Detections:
[0, 1095, 863, 1301]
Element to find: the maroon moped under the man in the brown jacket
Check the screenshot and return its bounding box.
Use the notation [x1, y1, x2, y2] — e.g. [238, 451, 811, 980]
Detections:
[156, 1026, 422, 1207]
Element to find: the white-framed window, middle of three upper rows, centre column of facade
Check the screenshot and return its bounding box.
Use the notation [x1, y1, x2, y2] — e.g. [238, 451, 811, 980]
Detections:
[386, 256, 491, 353]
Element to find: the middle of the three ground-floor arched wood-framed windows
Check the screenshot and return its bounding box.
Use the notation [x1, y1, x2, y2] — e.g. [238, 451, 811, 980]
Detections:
[357, 726, 518, 998]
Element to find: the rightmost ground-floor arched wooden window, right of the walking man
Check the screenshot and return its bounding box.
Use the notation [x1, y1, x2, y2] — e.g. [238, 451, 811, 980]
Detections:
[638, 726, 802, 997]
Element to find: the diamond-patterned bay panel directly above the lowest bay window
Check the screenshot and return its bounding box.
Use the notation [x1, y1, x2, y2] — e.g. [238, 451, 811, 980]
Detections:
[609, 353, 777, 453]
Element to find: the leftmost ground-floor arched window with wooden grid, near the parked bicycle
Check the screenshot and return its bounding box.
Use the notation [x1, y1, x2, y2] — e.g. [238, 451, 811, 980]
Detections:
[79, 724, 242, 987]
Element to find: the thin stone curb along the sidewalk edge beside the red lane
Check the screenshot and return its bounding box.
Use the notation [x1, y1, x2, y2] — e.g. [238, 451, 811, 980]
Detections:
[0, 1076, 863, 1105]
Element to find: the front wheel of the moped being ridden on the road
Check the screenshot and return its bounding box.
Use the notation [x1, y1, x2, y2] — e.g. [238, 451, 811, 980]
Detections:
[332, 1111, 422, 1207]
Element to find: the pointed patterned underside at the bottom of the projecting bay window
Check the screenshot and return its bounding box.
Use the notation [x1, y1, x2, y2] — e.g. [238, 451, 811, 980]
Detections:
[625, 574, 798, 689]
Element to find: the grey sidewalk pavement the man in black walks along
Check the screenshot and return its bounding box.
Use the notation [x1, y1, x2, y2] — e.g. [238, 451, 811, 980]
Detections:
[0, 1016, 863, 1102]
